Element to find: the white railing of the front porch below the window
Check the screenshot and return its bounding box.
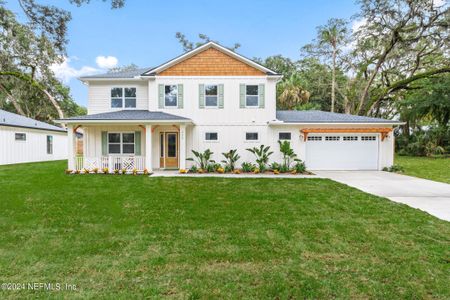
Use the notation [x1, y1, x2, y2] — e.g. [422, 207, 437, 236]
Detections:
[75, 156, 145, 173]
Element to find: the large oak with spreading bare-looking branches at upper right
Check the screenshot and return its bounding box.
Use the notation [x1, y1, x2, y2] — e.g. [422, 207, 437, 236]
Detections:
[351, 0, 450, 114]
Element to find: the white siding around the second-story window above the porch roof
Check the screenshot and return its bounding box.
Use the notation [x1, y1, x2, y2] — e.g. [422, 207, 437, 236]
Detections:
[88, 81, 148, 114]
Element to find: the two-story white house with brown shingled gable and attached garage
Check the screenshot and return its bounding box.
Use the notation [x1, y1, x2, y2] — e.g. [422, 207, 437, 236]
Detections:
[60, 42, 398, 171]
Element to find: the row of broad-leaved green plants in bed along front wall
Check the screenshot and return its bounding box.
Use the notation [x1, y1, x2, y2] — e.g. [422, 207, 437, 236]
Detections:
[180, 141, 312, 175]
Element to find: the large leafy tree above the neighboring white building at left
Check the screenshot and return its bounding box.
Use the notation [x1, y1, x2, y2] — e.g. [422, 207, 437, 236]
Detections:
[0, 0, 125, 121]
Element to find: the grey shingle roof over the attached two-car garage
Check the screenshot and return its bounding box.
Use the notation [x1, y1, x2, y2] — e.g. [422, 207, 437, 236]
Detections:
[277, 110, 401, 124]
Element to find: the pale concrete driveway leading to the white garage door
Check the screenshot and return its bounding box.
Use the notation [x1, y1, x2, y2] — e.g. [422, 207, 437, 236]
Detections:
[313, 171, 450, 221]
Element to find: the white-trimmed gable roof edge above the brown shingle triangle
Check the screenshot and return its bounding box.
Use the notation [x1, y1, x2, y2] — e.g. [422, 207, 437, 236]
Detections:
[142, 42, 280, 76]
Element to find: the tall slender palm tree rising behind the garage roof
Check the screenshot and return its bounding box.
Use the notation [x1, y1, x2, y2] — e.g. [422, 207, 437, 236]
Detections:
[303, 19, 348, 112]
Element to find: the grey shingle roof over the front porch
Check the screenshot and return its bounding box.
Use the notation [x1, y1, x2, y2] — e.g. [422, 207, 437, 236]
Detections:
[60, 110, 190, 121]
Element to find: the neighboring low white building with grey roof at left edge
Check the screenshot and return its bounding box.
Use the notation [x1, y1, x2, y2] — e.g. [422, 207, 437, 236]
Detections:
[0, 109, 67, 165]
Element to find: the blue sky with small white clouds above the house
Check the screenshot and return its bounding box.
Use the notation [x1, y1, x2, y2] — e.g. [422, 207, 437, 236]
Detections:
[6, 0, 358, 106]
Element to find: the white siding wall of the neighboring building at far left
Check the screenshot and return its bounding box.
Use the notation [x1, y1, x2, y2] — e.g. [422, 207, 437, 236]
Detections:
[0, 126, 67, 165]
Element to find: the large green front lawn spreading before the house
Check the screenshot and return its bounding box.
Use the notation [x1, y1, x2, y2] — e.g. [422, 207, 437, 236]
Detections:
[0, 162, 450, 299]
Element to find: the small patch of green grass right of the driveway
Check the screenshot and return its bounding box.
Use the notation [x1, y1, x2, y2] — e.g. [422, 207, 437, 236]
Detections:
[395, 155, 450, 183]
